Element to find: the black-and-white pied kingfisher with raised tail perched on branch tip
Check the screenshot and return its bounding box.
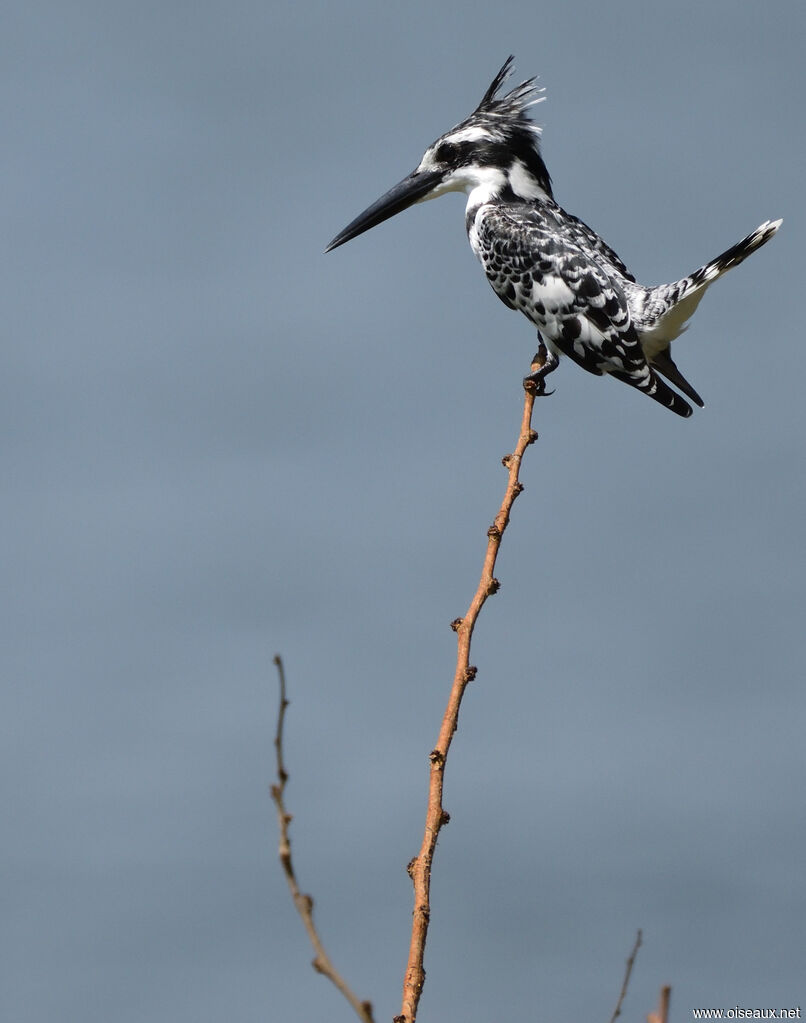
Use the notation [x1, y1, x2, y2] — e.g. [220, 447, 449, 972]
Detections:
[325, 56, 781, 416]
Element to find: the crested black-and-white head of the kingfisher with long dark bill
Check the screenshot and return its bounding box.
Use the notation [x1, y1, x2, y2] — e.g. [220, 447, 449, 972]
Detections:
[325, 57, 551, 252]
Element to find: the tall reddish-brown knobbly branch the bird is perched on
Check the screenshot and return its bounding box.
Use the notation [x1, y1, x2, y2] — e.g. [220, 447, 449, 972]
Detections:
[395, 352, 543, 1023]
